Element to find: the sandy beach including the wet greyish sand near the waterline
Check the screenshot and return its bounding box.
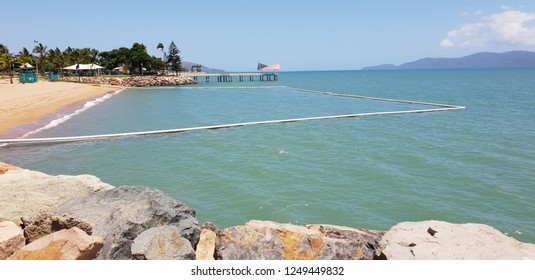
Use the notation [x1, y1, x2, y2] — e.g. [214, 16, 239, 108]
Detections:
[0, 81, 119, 139]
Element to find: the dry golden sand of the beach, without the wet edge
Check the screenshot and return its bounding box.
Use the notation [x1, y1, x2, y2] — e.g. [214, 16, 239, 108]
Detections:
[0, 79, 118, 134]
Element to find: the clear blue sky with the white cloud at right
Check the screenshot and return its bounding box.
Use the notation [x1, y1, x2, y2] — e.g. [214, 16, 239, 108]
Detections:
[0, 0, 535, 71]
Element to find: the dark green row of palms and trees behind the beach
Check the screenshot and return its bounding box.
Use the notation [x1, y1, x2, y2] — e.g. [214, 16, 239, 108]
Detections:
[0, 41, 184, 74]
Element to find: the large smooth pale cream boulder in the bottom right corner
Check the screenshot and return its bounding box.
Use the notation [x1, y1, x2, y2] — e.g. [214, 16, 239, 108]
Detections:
[380, 221, 535, 260]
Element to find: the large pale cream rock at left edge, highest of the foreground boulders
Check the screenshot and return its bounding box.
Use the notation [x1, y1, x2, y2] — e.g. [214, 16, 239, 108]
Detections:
[0, 169, 113, 224]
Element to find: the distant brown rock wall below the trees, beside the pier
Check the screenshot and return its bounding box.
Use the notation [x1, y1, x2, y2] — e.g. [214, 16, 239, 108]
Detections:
[61, 74, 197, 87]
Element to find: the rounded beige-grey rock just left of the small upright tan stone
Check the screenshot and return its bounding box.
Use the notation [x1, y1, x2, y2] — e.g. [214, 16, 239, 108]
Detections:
[132, 226, 195, 260]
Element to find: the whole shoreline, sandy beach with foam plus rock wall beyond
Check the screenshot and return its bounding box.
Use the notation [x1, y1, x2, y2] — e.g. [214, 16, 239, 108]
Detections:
[0, 75, 197, 139]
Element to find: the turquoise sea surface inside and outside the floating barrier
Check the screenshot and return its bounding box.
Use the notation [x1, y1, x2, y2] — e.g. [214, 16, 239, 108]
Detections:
[0, 69, 535, 243]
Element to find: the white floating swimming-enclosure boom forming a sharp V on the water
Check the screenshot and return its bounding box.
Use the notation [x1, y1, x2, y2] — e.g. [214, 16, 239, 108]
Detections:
[0, 87, 465, 146]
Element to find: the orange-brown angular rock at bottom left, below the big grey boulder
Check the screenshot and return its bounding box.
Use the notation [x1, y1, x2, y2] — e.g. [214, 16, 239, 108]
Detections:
[9, 227, 102, 260]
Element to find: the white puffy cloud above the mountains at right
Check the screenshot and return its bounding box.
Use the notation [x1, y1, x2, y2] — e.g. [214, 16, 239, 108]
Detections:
[440, 7, 535, 47]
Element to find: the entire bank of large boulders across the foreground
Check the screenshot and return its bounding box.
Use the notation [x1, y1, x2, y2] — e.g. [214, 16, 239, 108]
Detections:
[0, 163, 535, 260]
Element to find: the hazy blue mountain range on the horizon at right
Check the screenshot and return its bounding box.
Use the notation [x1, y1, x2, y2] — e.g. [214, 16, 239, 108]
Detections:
[362, 51, 535, 70]
